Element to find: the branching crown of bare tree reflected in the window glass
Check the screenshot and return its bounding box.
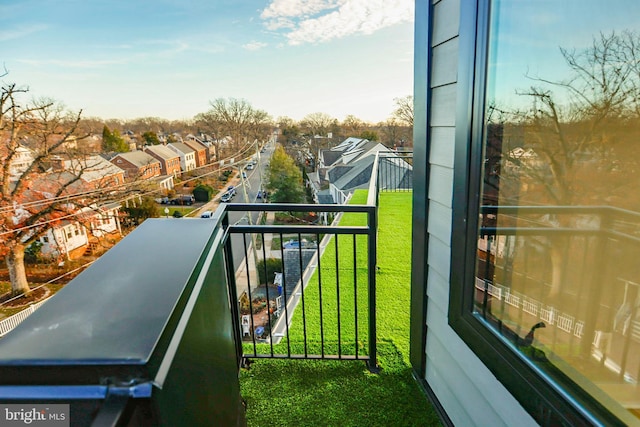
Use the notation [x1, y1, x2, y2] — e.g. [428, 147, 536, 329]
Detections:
[500, 32, 640, 205]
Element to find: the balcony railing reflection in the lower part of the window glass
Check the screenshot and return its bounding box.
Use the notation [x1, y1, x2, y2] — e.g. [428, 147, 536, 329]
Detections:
[474, 206, 640, 419]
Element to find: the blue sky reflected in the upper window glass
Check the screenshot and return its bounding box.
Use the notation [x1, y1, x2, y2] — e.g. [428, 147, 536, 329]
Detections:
[488, 0, 640, 112]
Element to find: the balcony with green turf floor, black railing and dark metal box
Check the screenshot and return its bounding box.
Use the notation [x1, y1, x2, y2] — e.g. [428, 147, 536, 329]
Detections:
[0, 153, 438, 425]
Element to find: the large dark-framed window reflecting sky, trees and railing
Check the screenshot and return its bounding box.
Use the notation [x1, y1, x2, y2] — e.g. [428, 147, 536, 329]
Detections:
[450, 0, 640, 424]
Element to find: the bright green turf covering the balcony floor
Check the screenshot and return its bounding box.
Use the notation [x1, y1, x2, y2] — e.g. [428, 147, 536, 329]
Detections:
[240, 191, 439, 426]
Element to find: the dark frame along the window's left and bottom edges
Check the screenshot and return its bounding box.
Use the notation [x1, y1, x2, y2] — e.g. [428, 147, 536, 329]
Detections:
[448, 0, 625, 425]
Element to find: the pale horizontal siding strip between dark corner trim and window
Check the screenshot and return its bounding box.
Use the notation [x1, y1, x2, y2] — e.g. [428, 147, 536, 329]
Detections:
[426, 0, 536, 426]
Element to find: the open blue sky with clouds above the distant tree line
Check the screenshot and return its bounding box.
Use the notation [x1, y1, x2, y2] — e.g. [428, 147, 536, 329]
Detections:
[0, 0, 414, 123]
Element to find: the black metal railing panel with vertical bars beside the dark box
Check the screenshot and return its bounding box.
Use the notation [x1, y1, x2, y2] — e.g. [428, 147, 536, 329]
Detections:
[221, 204, 377, 370]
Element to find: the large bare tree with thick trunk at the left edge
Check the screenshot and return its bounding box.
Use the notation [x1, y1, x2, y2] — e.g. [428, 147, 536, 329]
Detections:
[0, 78, 130, 294]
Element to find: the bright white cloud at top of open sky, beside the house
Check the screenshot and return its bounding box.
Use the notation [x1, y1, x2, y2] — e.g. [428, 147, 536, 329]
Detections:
[261, 0, 414, 45]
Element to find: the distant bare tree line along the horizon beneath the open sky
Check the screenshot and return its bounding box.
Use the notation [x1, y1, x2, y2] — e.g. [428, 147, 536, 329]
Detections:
[79, 96, 413, 157]
